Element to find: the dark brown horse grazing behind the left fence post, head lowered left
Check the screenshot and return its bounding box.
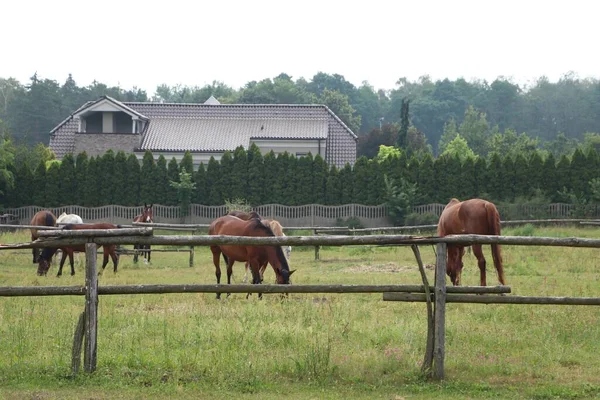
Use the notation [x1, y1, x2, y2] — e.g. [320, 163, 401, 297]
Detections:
[38, 223, 121, 276]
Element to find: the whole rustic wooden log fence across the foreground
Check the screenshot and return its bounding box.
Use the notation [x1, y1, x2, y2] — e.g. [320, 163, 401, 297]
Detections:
[0, 228, 600, 379]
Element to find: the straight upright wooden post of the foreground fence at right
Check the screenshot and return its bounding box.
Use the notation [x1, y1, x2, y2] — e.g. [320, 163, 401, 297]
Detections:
[433, 243, 447, 380]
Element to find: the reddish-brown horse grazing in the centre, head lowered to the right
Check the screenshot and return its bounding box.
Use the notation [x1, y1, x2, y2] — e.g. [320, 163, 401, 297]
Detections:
[208, 215, 294, 299]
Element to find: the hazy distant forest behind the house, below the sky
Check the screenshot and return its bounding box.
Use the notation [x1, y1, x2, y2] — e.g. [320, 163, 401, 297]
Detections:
[0, 72, 600, 158]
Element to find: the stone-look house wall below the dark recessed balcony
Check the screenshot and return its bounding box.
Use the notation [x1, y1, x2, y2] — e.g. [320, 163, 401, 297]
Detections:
[73, 133, 140, 157]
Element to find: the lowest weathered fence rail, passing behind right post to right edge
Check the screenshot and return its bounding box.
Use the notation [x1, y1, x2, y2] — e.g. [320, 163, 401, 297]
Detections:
[383, 287, 600, 306]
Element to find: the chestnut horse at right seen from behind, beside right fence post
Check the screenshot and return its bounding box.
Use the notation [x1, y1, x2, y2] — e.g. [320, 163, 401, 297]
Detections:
[437, 198, 505, 286]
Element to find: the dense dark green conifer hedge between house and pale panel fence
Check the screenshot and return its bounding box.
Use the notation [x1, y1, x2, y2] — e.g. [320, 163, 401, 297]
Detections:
[1, 145, 600, 222]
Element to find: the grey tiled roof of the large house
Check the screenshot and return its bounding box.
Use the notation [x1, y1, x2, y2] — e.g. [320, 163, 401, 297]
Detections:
[50, 99, 357, 166]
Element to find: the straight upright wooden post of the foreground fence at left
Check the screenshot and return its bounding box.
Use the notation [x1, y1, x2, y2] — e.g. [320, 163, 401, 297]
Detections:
[83, 243, 98, 372]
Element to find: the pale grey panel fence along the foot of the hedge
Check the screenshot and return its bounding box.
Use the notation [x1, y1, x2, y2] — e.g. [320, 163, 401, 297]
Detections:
[0, 203, 600, 228]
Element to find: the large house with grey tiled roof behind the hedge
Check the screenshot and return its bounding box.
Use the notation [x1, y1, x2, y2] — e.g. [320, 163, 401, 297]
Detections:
[50, 96, 358, 167]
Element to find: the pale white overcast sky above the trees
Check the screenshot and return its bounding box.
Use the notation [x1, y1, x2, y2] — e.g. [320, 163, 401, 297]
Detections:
[0, 0, 600, 95]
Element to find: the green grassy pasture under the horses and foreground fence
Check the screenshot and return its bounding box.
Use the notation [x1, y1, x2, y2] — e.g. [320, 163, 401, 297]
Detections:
[0, 226, 600, 400]
